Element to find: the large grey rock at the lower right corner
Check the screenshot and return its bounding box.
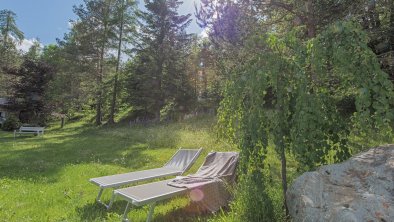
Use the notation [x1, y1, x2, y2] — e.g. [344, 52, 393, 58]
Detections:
[286, 145, 394, 222]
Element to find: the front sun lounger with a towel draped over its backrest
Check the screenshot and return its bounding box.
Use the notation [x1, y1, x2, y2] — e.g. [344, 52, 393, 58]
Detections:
[114, 152, 238, 222]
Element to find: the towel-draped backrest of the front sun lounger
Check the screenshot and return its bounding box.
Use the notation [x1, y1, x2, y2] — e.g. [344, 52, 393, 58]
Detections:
[193, 152, 239, 178]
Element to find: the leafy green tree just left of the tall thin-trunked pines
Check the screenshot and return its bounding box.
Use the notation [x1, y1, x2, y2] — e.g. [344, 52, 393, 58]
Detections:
[40, 41, 86, 126]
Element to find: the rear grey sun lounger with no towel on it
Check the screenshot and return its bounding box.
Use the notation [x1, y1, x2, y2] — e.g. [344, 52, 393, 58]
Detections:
[89, 148, 202, 209]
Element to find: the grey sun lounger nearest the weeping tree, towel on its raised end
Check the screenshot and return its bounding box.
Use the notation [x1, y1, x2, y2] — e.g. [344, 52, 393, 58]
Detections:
[114, 152, 238, 222]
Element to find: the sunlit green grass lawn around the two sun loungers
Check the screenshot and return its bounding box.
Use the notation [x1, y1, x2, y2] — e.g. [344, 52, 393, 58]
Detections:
[0, 117, 242, 221]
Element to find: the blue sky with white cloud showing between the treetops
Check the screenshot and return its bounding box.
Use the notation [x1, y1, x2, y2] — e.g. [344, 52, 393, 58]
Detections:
[0, 0, 202, 51]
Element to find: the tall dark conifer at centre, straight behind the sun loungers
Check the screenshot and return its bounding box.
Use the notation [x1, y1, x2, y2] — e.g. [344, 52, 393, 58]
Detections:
[127, 0, 191, 120]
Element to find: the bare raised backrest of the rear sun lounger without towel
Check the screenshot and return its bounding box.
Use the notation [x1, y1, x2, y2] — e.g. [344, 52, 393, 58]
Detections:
[164, 148, 202, 172]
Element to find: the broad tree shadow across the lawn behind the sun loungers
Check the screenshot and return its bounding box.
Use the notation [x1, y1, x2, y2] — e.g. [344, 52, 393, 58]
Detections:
[0, 123, 182, 183]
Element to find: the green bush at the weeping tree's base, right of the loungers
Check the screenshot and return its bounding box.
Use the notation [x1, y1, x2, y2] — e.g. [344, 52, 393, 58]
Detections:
[223, 148, 287, 222]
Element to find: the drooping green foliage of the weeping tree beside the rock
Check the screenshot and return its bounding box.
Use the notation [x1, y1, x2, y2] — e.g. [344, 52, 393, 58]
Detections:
[215, 19, 394, 220]
